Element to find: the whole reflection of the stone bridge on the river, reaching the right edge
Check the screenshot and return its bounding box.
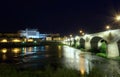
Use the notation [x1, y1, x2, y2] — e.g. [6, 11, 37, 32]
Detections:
[63, 46, 120, 77]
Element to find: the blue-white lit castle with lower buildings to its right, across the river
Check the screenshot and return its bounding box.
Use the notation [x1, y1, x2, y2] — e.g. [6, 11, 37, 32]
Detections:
[19, 29, 60, 41]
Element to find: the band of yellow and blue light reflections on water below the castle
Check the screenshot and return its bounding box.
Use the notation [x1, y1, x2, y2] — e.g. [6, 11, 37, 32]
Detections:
[0, 46, 49, 62]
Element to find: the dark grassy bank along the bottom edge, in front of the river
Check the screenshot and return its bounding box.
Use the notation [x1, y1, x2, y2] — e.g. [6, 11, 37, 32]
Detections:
[0, 64, 105, 77]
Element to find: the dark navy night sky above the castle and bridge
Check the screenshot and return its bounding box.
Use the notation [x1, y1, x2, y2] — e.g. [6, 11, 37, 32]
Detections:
[0, 0, 120, 35]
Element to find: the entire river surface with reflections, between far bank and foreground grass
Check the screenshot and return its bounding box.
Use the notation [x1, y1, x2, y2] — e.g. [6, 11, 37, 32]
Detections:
[0, 46, 120, 77]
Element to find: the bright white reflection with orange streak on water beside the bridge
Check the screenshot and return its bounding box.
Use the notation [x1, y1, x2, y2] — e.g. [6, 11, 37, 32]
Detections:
[63, 46, 92, 75]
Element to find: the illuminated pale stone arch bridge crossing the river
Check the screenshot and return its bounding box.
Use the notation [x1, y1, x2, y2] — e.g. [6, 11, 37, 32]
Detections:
[65, 29, 120, 57]
